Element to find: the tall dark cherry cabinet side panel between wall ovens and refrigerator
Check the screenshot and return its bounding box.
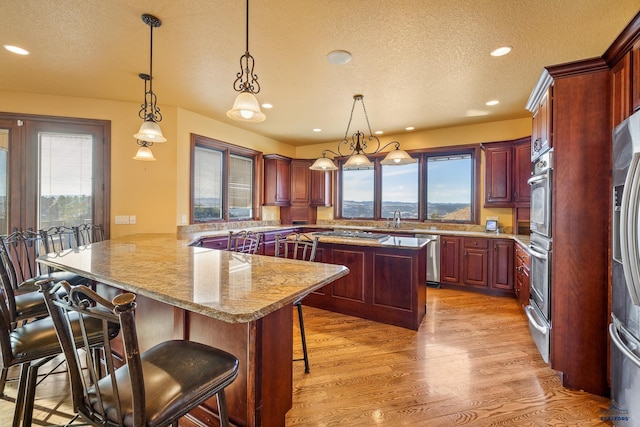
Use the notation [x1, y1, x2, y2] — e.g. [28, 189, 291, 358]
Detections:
[527, 58, 612, 396]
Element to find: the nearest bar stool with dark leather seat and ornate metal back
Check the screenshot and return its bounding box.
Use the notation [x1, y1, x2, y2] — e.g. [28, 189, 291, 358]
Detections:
[42, 282, 238, 427]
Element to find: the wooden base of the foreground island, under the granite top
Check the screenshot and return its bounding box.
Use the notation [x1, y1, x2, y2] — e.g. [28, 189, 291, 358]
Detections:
[106, 285, 293, 427]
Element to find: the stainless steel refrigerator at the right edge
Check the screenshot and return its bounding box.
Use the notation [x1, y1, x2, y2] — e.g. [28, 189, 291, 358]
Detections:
[602, 112, 640, 427]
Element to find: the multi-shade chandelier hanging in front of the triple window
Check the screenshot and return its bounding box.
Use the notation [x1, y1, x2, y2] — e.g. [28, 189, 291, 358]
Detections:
[309, 95, 418, 171]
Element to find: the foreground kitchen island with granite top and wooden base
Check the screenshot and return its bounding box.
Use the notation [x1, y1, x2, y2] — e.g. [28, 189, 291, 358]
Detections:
[38, 234, 349, 426]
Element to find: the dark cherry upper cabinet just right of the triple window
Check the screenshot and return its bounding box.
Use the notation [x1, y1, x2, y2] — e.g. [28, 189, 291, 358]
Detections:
[482, 137, 531, 208]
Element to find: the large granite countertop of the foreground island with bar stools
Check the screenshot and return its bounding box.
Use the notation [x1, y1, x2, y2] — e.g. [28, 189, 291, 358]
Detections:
[38, 234, 349, 323]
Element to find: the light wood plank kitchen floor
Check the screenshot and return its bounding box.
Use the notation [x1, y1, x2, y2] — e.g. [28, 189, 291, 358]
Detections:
[0, 288, 609, 427]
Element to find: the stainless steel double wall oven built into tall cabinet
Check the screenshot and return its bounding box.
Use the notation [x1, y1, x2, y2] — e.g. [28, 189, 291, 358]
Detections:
[526, 151, 553, 363]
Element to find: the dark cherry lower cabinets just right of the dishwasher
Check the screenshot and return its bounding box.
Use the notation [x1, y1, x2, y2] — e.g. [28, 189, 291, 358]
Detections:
[440, 236, 514, 293]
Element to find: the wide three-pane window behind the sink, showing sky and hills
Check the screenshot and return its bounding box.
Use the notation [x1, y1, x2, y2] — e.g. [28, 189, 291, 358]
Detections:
[336, 145, 480, 223]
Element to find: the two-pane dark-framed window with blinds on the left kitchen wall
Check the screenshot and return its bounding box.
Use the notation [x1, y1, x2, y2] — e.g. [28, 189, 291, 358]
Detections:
[191, 135, 262, 223]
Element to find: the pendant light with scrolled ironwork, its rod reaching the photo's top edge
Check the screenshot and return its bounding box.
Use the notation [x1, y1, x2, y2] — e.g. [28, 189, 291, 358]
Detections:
[227, 0, 266, 123]
